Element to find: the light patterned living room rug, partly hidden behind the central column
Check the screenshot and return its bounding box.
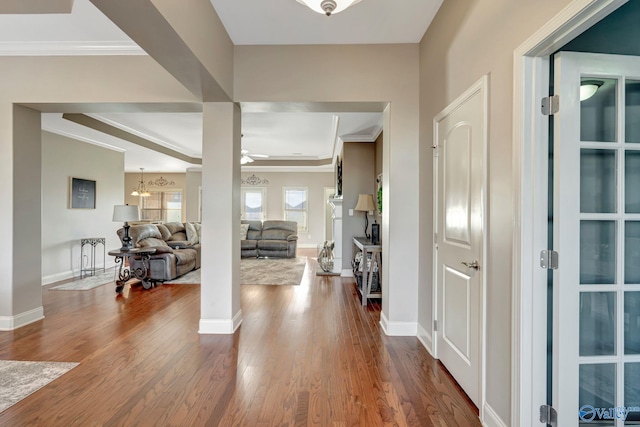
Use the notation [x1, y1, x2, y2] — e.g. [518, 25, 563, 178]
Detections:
[164, 257, 307, 285]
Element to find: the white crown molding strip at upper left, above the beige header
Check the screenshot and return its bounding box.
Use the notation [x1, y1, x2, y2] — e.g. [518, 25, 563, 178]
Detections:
[0, 41, 147, 56]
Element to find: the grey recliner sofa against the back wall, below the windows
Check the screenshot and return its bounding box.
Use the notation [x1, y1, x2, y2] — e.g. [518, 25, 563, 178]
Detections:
[240, 220, 298, 258]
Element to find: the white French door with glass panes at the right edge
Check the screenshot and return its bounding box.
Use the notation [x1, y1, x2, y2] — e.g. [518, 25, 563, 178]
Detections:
[552, 52, 640, 427]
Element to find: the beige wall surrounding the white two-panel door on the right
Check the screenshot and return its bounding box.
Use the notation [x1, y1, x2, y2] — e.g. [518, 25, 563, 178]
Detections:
[419, 0, 570, 425]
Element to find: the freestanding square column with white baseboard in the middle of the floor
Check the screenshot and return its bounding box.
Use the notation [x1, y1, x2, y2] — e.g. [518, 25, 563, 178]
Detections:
[199, 102, 242, 334]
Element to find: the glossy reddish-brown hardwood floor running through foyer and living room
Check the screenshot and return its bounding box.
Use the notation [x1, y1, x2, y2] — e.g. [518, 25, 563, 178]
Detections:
[0, 251, 481, 427]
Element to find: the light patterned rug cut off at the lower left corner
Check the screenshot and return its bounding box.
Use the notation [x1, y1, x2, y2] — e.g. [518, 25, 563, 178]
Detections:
[0, 360, 78, 412]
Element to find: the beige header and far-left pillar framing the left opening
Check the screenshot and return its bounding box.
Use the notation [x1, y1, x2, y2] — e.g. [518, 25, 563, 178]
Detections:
[0, 56, 195, 329]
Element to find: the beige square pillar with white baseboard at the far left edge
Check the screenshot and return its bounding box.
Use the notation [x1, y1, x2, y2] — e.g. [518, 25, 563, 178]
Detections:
[0, 105, 44, 331]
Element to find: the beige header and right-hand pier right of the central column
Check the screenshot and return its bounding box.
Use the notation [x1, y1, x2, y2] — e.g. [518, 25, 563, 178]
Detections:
[234, 44, 419, 335]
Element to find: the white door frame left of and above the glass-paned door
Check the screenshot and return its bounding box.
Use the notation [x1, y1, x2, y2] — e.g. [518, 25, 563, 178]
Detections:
[511, 0, 627, 427]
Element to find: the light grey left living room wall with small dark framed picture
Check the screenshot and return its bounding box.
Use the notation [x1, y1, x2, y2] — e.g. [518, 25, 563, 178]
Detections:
[42, 132, 124, 284]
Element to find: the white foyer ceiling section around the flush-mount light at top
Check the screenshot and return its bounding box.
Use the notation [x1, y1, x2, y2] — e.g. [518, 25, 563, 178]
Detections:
[211, 0, 443, 45]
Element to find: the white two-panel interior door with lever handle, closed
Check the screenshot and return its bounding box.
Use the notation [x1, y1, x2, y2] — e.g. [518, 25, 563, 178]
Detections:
[434, 77, 487, 407]
